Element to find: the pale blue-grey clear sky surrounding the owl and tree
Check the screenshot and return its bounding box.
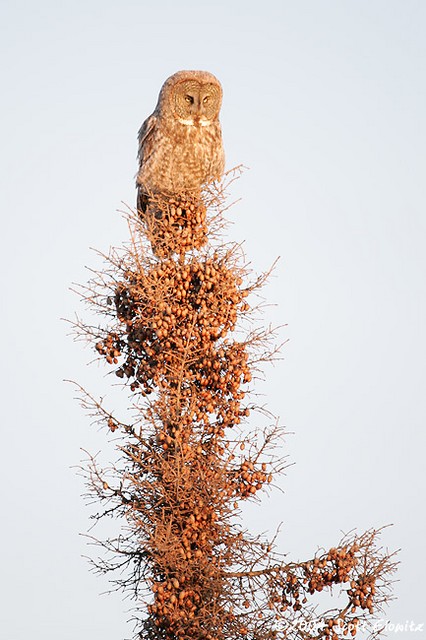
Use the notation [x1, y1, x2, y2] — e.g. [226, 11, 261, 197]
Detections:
[0, 0, 426, 640]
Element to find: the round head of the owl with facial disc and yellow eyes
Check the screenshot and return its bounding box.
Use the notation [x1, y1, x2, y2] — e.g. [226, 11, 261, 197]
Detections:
[157, 71, 222, 126]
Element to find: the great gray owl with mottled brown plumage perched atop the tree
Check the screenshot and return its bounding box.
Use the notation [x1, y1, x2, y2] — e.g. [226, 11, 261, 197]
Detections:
[136, 71, 225, 213]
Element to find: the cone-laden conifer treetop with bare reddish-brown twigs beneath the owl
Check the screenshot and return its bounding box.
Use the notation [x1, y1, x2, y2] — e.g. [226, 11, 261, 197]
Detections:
[75, 173, 396, 640]
